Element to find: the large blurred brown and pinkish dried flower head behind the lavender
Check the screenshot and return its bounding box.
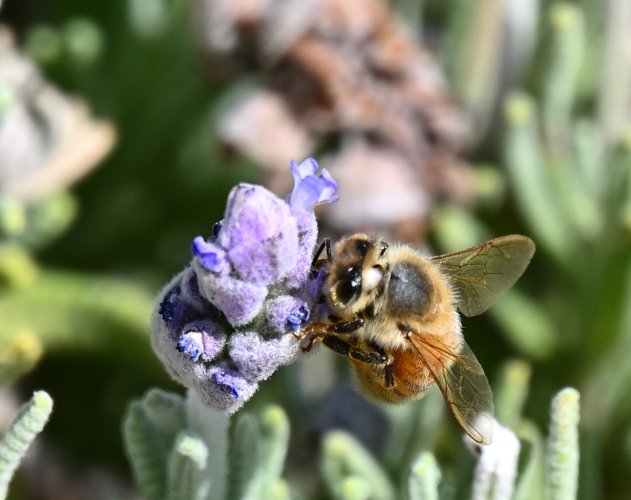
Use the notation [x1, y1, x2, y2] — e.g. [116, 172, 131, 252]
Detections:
[197, 0, 470, 240]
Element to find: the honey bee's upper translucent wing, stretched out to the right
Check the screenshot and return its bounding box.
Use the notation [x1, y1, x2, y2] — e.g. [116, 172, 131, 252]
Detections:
[430, 234, 535, 316]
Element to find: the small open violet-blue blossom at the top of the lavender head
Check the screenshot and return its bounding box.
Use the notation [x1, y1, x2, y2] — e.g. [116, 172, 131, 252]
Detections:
[289, 158, 339, 211]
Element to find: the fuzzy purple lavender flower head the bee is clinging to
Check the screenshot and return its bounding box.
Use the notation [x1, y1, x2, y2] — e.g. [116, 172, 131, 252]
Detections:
[151, 158, 337, 413]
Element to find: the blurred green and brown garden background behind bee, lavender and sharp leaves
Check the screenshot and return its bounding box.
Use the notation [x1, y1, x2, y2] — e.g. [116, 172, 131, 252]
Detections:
[0, 0, 631, 499]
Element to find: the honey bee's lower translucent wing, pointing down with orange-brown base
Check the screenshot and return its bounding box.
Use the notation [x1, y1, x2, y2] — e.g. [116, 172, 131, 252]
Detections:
[408, 332, 493, 444]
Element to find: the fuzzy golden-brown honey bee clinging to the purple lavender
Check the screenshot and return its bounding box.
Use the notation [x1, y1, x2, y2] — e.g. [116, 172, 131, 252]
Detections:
[298, 234, 535, 444]
